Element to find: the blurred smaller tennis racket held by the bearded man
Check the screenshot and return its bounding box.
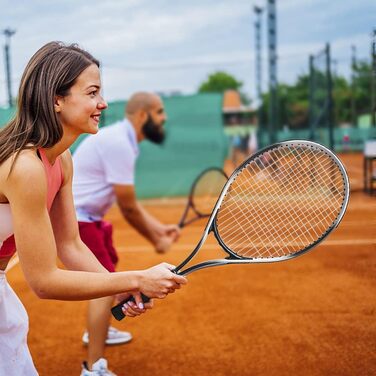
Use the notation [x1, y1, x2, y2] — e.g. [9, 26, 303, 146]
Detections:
[178, 167, 228, 228]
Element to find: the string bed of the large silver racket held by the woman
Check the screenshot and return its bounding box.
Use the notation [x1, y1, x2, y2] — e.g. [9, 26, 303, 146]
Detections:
[216, 146, 344, 258]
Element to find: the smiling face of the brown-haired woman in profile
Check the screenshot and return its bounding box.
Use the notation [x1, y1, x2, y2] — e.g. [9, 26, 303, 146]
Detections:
[55, 64, 107, 135]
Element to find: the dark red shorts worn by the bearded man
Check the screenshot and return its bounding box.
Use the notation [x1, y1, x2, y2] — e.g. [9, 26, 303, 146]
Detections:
[78, 221, 118, 272]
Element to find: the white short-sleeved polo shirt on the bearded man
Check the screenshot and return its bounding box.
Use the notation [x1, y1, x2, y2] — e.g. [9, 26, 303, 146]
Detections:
[73, 119, 139, 222]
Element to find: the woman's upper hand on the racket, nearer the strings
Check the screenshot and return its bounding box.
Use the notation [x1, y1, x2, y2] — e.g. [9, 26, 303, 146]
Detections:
[139, 262, 187, 299]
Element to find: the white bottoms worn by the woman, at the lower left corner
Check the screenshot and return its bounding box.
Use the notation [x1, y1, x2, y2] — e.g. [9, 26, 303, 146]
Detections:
[0, 270, 38, 376]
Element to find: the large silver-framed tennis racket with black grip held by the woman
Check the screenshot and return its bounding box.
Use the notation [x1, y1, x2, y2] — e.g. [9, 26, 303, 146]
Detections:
[112, 140, 350, 320]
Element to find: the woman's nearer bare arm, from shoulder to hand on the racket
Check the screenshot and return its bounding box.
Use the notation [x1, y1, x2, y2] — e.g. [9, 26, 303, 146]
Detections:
[3, 151, 185, 300]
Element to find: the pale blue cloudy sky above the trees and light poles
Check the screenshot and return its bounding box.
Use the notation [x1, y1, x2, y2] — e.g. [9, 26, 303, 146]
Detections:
[0, 0, 376, 106]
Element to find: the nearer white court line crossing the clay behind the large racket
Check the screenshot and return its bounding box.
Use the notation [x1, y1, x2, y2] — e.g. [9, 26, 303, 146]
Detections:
[117, 239, 376, 254]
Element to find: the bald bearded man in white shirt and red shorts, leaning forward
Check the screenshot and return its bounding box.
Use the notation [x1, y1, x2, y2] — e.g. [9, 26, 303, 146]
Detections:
[73, 92, 179, 375]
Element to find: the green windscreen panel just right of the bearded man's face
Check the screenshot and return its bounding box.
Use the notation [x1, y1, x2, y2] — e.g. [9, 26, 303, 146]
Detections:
[136, 94, 228, 197]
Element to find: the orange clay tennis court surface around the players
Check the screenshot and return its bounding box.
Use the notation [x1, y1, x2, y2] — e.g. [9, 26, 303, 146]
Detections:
[4, 154, 376, 376]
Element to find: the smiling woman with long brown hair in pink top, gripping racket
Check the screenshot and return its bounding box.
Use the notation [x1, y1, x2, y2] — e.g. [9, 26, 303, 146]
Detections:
[0, 42, 186, 376]
